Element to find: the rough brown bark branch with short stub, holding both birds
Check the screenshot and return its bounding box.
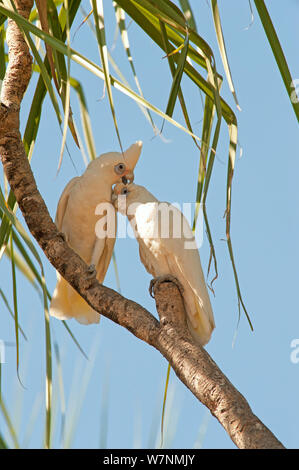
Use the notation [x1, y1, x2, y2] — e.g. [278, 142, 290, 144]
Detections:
[0, 0, 283, 449]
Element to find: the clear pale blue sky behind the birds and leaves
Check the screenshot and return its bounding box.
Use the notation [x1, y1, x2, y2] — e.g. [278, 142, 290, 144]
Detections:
[0, 0, 299, 448]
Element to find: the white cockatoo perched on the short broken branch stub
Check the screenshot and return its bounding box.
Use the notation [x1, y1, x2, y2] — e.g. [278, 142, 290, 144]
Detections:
[112, 183, 215, 346]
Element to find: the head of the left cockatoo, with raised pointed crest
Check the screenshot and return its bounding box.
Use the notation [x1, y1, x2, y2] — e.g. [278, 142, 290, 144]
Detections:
[85, 140, 142, 186]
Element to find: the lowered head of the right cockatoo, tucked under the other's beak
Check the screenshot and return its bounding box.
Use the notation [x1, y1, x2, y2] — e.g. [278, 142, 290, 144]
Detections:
[112, 183, 152, 214]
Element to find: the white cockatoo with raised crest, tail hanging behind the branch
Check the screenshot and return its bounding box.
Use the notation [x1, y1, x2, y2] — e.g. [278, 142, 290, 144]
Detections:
[50, 141, 142, 325]
